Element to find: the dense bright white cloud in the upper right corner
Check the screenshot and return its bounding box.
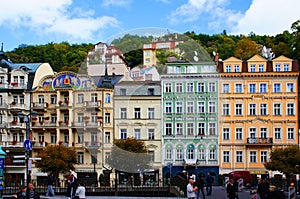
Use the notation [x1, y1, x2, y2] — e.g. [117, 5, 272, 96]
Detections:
[230, 0, 300, 35]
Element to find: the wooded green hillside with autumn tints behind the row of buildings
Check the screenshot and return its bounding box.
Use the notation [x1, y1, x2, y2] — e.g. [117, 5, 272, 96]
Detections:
[6, 20, 300, 72]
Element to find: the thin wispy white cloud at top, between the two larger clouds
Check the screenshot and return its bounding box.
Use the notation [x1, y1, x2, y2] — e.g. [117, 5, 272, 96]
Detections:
[169, 0, 228, 24]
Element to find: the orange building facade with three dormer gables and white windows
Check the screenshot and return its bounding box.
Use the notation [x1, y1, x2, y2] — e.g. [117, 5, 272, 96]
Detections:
[218, 55, 299, 174]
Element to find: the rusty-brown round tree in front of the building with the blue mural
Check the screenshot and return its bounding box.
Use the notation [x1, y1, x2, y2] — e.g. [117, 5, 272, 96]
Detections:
[35, 145, 77, 177]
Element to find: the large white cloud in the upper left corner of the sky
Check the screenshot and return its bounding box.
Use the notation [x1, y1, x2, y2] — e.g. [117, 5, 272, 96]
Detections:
[0, 0, 118, 39]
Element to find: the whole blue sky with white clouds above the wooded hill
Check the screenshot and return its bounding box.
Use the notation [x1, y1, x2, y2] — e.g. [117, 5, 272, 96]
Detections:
[0, 0, 300, 51]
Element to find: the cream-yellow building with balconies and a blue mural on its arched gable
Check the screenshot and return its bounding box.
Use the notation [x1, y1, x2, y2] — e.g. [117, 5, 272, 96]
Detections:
[31, 72, 113, 182]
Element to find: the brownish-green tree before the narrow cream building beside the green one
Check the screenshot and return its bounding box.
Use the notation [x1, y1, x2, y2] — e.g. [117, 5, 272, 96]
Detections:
[108, 138, 150, 173]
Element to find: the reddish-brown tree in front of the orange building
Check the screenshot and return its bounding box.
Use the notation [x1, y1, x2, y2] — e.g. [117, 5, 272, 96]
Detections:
[265, 146, 300, 174]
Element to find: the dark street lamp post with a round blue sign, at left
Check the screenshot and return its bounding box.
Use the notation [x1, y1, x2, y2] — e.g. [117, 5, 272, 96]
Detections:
[18, 111, 38, 199]
